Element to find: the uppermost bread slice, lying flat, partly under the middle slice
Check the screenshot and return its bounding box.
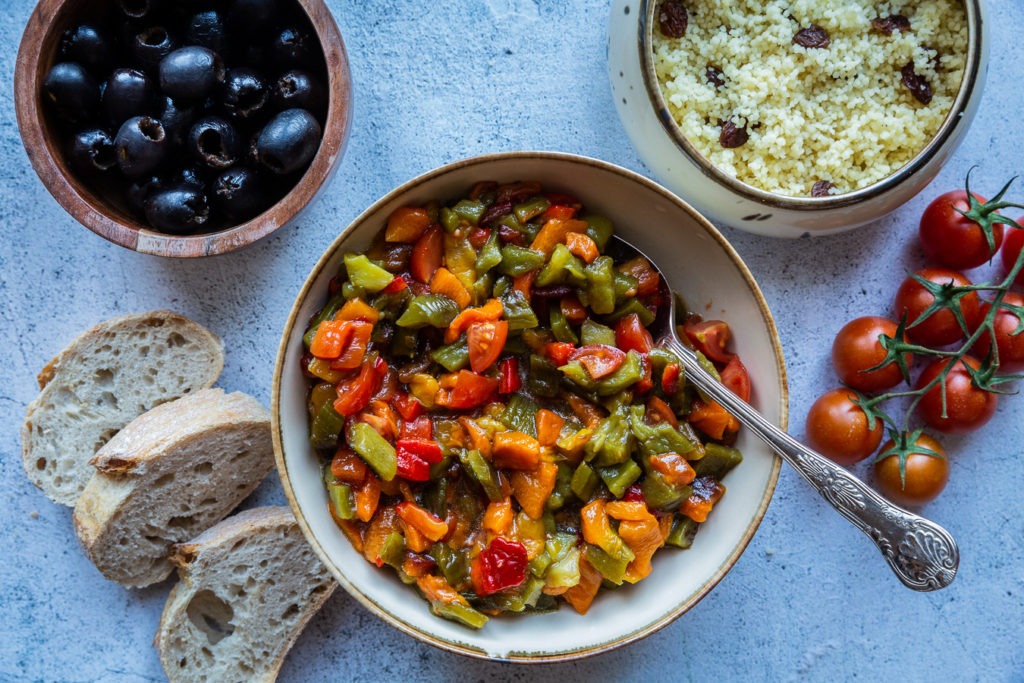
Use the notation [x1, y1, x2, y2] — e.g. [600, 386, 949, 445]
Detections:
[22, 310, 224, 506]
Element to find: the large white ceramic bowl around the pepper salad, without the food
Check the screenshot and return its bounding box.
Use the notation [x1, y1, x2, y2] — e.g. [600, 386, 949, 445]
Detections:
[271, 153, 787, 660]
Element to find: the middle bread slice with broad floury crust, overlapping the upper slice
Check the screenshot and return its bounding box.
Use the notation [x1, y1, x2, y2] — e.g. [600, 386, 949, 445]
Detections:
[75, 389, 273, 588]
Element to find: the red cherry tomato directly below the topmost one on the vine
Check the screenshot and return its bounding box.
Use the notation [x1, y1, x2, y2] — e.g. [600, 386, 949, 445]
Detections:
[895, 268, 980, 347]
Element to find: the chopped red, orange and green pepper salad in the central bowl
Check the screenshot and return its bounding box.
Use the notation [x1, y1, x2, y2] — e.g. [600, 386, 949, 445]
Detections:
[302, 182, 750, 628]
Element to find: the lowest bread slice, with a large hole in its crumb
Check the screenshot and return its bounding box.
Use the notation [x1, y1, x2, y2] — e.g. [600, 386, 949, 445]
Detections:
[154, 507, 338, 683]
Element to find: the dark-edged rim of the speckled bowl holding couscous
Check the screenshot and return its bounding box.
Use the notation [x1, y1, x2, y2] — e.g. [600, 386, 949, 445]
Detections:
[637, 0, 984, 212]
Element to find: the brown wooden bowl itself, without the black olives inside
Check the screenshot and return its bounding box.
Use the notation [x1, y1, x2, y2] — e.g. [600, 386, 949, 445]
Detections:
[14, 0, 351, 258]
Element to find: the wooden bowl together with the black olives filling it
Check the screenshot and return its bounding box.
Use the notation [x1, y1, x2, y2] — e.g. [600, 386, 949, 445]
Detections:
[14, 0, 351, 257]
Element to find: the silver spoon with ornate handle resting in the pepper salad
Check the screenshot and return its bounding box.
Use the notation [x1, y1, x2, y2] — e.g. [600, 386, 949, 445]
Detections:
[614, 236, 959, 591]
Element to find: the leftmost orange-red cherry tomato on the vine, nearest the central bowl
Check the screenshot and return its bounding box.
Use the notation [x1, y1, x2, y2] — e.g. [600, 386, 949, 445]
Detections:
[806, 388, 885, 467]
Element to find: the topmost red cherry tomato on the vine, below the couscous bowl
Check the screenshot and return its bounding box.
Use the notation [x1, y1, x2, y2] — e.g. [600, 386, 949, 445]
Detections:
[919, 189, 1002, 270]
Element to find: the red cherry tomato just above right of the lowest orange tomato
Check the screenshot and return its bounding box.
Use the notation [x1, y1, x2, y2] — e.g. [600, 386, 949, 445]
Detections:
[916, 355, 999, 433]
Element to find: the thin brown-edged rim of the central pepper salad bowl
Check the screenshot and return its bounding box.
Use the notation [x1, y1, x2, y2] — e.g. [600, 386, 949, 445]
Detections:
[270, 152, 788, 664]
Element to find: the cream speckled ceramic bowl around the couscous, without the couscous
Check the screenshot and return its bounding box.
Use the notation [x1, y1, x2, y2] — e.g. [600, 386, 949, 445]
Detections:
[608, 0, 988, 238]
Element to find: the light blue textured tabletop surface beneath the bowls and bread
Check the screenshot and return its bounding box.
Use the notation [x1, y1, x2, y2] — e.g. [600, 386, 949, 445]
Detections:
[0, 0, 1024, 682]
